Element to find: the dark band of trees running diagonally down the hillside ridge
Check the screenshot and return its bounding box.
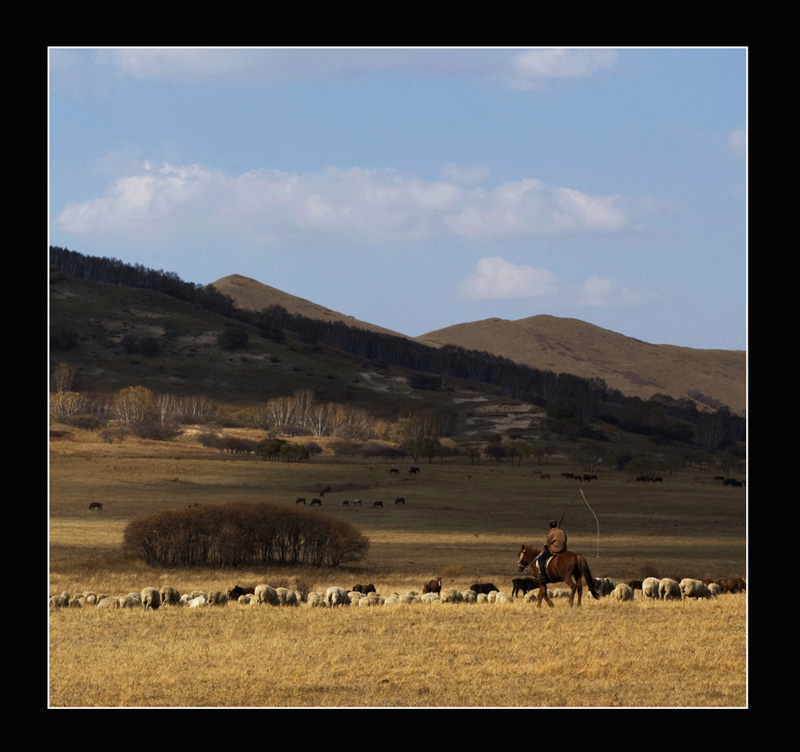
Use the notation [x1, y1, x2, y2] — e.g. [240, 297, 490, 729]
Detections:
[50, 246, 746, 453]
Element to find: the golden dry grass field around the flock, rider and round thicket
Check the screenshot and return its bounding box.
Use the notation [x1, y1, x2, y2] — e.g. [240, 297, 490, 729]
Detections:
[48, 430, 747, 708]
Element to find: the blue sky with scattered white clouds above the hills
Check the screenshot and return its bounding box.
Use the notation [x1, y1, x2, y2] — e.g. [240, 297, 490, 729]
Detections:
[48, 47, 748, 350]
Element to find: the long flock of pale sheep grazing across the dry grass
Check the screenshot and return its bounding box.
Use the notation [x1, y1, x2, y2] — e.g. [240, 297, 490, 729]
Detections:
[50, 577, 746, 610]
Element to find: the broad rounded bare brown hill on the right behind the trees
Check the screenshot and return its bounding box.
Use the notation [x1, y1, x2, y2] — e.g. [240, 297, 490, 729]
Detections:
[417, 315, 747, 415]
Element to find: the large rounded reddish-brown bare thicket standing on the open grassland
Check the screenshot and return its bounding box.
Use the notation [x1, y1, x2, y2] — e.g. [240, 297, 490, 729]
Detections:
[123, 502, 369, 567]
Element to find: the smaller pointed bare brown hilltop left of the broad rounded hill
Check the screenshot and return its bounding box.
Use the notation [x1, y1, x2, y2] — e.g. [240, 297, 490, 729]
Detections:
[211, 274, 406, 337]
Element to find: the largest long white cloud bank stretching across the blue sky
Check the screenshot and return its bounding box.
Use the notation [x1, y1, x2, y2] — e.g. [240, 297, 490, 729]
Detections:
[58, 162, 629, 241]
